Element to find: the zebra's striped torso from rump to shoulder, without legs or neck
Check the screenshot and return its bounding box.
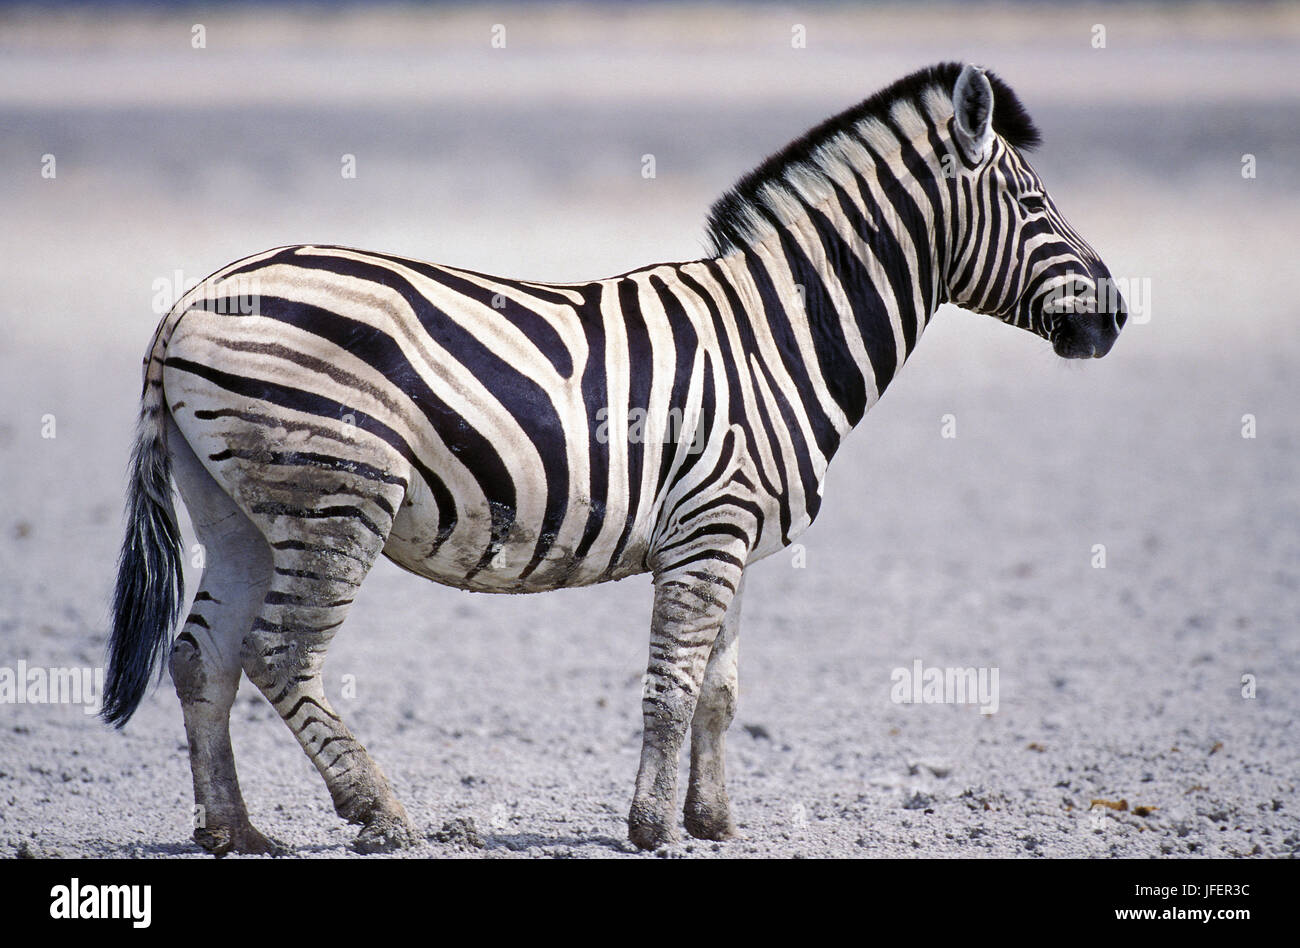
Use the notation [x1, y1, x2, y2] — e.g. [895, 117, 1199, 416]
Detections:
[164, 232, 923, 593]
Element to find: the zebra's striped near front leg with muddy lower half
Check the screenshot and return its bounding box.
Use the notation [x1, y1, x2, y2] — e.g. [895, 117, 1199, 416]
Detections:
[628, 558, 744, 849]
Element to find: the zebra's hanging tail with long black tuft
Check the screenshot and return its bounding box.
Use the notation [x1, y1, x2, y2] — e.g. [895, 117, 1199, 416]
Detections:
[100, 320, 185, 727]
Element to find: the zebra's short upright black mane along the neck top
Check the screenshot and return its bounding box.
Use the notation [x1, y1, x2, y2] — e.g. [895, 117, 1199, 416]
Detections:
[705, 62, 1043, 254]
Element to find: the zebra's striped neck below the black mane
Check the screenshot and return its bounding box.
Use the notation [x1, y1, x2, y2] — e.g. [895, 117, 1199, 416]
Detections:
[716, 105, 950, 450]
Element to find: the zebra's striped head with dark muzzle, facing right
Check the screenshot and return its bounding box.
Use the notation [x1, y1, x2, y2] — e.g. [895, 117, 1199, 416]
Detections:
[946, 65, 1127, 359]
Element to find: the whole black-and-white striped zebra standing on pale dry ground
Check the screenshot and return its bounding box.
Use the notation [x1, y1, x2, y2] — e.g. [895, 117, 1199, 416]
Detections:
[103, 62, 1126, 854]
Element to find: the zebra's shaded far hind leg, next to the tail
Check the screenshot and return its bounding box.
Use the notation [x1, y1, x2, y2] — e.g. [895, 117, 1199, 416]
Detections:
[168, 423, 282, 856]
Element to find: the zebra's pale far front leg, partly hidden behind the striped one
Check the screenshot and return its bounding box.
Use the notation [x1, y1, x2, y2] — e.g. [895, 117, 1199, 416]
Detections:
[685, 579, 744, 840]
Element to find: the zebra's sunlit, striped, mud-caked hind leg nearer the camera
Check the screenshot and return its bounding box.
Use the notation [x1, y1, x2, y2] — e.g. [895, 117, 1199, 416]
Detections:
[236, 489, 416, 852]
